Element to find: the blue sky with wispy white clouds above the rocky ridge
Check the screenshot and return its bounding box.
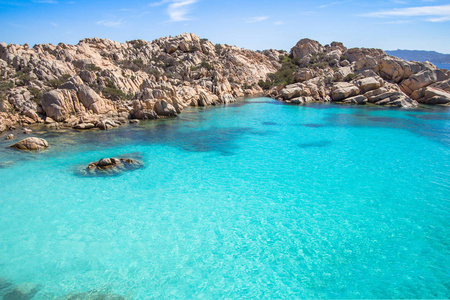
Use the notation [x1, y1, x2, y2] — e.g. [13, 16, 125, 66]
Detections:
[0, 0, 450, 53]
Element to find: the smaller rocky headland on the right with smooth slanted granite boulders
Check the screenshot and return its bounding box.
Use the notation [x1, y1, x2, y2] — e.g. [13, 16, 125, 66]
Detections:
[261, 39, 450, 108]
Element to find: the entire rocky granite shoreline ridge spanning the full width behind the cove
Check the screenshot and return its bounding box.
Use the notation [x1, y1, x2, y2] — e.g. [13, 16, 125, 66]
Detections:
[0, 33, 450, 132]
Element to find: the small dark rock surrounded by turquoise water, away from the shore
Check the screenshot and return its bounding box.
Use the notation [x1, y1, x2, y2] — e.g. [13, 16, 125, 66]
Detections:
[78, 157, 144, 176]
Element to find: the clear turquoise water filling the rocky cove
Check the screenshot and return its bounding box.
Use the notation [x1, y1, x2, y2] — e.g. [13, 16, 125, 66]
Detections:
[0, 98, 450, 299]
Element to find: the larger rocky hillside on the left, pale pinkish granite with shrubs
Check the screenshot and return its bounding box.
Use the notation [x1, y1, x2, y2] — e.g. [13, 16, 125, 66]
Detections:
[0, 33, 279, 131]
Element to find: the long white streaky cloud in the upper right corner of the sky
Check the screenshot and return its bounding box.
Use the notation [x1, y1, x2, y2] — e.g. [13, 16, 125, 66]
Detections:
[363, 5, 450, 22]
